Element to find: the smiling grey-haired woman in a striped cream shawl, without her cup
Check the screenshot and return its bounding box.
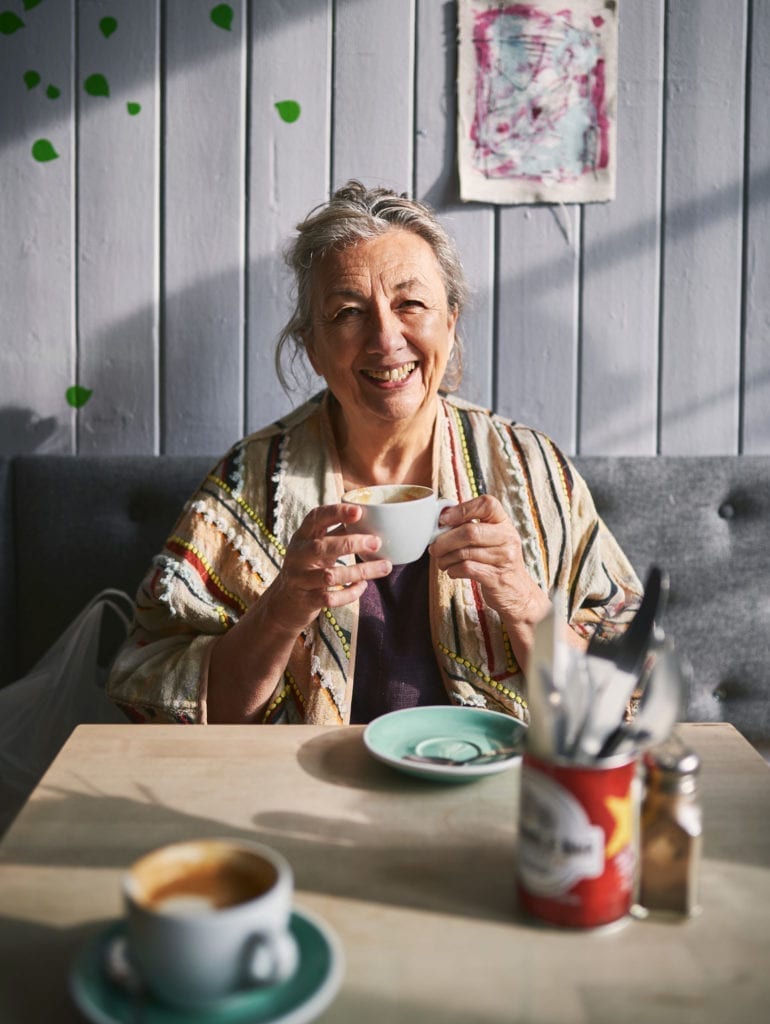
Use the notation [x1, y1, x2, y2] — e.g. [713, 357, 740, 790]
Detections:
[109, 181, 641, 724]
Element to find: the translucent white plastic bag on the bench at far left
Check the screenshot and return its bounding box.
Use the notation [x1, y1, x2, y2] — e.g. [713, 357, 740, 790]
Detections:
[0, 590, 133, 836]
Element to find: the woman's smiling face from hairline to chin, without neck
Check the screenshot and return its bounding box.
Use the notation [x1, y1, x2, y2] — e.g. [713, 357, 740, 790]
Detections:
[305, 228, 457, 427]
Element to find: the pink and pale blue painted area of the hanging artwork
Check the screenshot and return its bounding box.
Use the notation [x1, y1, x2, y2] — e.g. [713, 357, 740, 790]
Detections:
[470, 3, 610, 183]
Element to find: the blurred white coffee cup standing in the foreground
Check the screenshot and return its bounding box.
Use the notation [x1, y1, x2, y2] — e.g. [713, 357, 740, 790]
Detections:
[123, 840, 298, 1010]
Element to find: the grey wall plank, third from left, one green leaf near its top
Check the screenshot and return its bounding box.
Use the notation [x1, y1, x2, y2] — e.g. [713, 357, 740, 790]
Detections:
[162, 0, 246, 455]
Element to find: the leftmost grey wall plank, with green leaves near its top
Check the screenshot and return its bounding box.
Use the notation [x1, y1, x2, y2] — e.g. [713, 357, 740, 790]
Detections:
[0, 0, 76, 455]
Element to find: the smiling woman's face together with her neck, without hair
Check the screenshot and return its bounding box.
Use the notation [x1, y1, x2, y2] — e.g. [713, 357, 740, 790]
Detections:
[303, 228, 459, 490]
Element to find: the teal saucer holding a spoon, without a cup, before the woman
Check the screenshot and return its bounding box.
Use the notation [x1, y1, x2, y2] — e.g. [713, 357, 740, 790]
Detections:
[363, 706, 526, 782]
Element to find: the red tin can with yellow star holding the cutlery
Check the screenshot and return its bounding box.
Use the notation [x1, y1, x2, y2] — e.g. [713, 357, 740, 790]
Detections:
[517, 754, 639, 928]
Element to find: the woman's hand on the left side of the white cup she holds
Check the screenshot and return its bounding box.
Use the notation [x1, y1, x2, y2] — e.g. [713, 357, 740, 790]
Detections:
[259, 503, 392, 637]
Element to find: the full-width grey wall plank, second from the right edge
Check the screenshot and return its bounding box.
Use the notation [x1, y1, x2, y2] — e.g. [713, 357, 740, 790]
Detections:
[660, 0, 745, 455]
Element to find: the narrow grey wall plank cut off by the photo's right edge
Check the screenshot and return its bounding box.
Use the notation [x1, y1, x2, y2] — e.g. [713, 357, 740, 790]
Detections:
[743, 0, 770, 455]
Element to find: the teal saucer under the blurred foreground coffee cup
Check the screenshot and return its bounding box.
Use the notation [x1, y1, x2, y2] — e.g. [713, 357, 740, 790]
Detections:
[70, 907, 343, 1024]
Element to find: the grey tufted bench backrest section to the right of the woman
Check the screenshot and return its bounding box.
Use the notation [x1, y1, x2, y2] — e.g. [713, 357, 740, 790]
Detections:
[574, 456, 770, 754]
